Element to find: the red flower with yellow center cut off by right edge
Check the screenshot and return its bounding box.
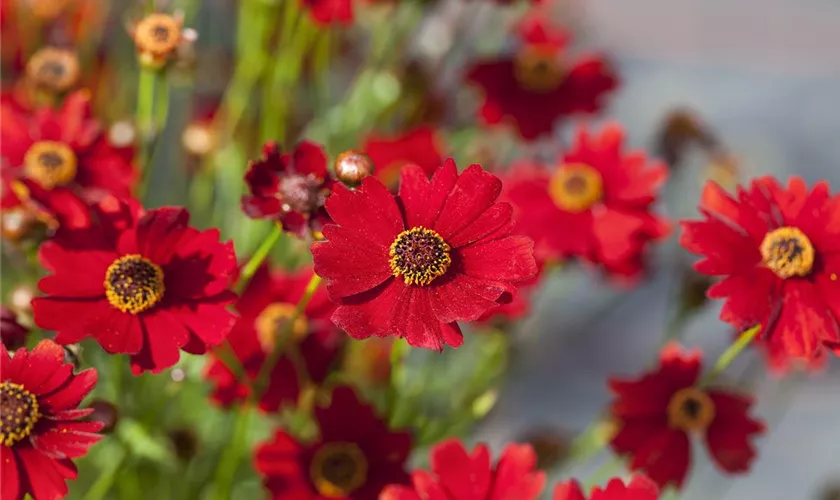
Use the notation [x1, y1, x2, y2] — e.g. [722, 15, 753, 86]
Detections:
[680, 177, 840, 359]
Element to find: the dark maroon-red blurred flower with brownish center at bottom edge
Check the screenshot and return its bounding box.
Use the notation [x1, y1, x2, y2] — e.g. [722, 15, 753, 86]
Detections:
[255, 387, 411, 500]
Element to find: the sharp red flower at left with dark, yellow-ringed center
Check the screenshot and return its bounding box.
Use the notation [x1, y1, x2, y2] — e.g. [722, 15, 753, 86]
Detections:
[32, 199, 236, 373]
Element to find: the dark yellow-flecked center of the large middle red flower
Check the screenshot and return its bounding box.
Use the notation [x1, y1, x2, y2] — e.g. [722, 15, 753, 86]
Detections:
[390, 226, 452, 286]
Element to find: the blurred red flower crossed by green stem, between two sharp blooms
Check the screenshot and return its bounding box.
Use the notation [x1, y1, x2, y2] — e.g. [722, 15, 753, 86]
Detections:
[207, 265, 341, 412]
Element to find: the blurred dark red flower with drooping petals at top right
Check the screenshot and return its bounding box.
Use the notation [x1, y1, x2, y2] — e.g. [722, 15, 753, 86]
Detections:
[466, 16, 618, 141]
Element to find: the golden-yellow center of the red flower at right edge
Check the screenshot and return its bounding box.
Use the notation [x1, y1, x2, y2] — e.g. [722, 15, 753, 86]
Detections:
[760, 227, 814, 279]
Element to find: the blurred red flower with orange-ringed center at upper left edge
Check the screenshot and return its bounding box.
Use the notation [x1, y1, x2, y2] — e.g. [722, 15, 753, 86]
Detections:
[0, 91, 137, 206]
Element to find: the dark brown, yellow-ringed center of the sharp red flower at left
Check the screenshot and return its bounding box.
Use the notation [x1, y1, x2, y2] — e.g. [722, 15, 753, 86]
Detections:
[105, 254, 166, 314]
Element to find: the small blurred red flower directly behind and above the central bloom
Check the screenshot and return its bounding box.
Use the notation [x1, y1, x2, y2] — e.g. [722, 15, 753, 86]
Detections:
[364, 126, 443, 186]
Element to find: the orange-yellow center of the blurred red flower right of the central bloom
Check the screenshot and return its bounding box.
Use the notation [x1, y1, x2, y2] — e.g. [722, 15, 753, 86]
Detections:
[548, 163, 604, 212]
